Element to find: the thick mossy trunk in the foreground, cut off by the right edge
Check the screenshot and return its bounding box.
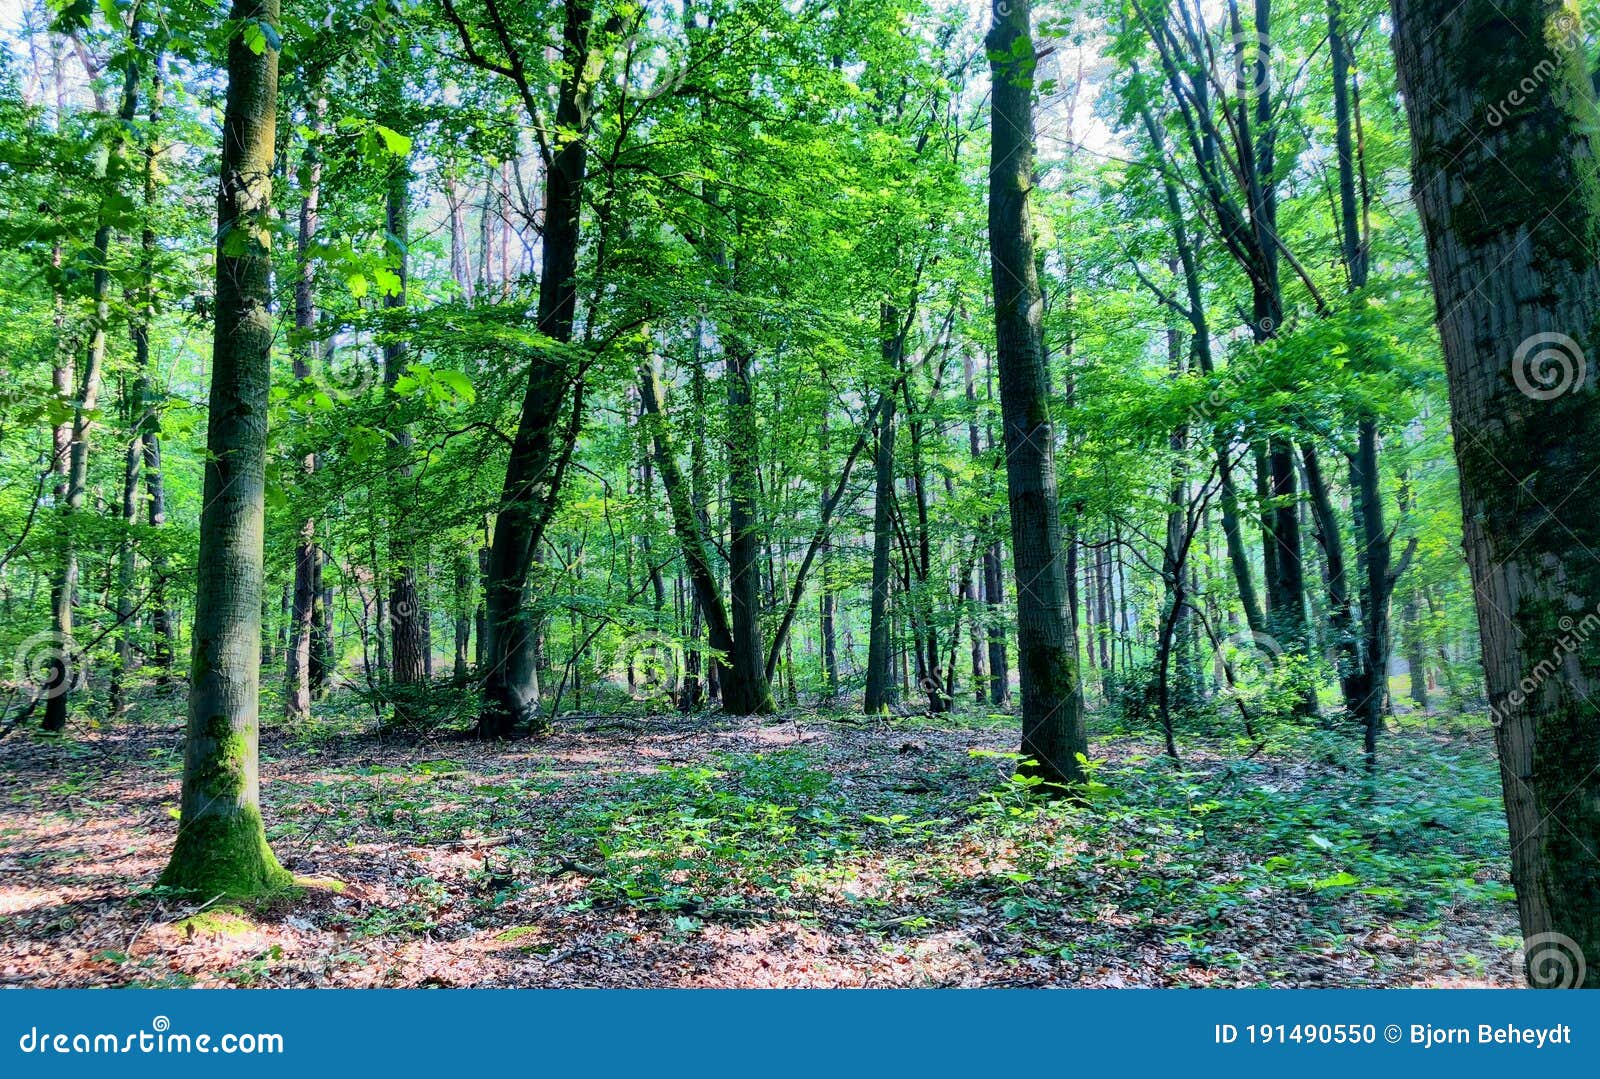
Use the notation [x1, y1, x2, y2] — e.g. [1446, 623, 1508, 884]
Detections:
[1394, 0, 1600, 988]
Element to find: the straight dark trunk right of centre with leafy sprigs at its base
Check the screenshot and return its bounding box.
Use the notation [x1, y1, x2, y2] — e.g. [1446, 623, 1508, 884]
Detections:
[986, 0, 1088, 784]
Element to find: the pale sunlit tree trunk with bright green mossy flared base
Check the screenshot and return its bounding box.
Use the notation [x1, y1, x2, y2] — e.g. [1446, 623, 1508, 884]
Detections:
[160, 0, 291, 900]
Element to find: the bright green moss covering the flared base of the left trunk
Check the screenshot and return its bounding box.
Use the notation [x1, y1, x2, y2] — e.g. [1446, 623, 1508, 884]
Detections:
[160, 805, 294, 900]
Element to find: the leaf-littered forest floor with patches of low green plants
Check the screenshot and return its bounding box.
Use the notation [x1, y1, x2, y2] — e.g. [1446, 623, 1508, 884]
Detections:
[0, 696, 1518, 988]
